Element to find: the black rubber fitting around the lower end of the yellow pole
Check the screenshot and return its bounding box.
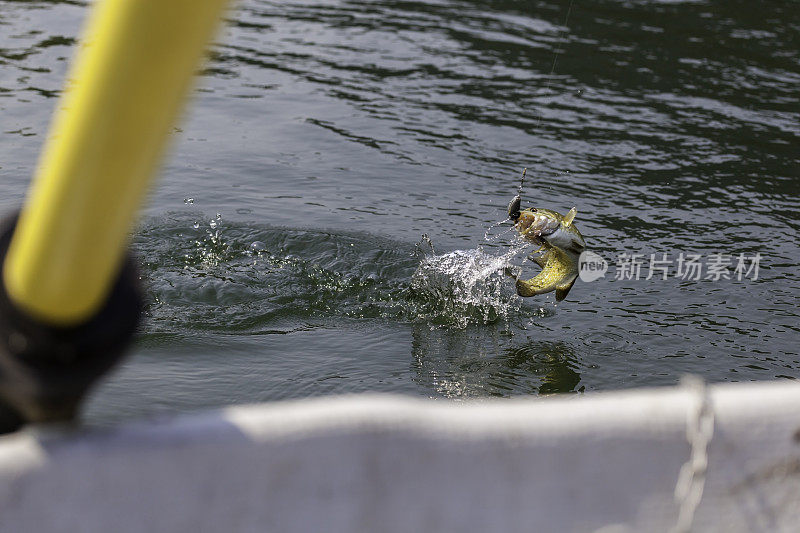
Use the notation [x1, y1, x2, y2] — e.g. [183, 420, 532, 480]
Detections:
[0, 215, 142, 433]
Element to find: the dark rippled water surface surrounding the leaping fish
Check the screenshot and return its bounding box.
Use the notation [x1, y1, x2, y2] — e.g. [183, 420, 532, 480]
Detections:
[0, 0, 800, 423]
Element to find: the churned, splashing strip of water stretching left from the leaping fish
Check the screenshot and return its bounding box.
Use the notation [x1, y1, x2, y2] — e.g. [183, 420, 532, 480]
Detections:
[134, 214, 540, 333]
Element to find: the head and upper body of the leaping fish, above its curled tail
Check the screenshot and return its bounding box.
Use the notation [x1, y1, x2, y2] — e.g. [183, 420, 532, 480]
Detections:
[515, 207, 586, 254]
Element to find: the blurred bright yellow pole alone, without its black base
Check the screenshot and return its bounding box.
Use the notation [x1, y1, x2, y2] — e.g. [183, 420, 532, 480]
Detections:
[3, 0, 226, 326]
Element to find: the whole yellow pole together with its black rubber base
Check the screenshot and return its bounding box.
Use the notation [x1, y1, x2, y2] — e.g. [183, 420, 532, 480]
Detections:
[0, 0, 231, 433]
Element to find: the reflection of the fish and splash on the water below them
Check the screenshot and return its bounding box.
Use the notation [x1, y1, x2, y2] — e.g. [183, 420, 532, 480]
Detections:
[412, 324, 584, 398]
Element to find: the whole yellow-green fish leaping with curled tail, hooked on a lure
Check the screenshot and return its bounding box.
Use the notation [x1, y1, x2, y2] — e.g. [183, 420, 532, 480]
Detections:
[508, 195, 586, 302]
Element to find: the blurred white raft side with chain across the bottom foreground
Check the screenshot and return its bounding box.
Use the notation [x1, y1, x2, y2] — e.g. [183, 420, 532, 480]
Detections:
[0, 383, 800, 533]
